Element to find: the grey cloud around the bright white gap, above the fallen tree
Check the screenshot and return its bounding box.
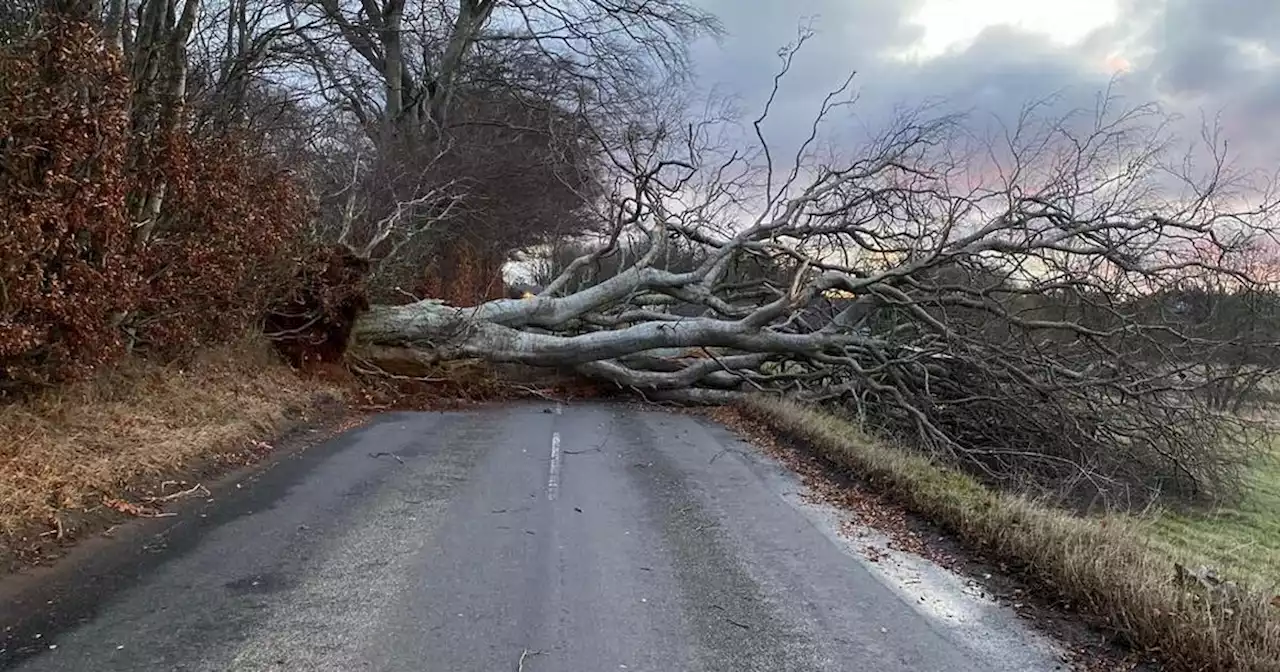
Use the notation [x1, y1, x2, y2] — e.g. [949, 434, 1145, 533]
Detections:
[695, 0, 1280, 165]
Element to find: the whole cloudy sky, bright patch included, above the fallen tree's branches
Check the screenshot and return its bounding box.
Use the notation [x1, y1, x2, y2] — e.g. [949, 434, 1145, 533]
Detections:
[694, 0, 1280, 169]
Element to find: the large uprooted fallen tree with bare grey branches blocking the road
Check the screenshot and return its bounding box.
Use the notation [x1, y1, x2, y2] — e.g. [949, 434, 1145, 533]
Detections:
[352, 39, 1275, 506]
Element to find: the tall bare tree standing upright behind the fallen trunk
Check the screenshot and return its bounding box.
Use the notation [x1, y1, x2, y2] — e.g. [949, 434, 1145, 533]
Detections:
[257, 0, 680, 300]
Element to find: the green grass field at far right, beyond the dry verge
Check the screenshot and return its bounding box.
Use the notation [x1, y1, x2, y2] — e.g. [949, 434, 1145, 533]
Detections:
[1149, 448, 1280, 590]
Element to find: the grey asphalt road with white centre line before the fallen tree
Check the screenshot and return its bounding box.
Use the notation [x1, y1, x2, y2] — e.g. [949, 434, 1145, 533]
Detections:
[0, 404, 1057, 672]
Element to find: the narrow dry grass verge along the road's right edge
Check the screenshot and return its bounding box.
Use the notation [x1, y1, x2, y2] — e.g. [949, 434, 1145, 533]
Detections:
[745, 398, 1280, 672]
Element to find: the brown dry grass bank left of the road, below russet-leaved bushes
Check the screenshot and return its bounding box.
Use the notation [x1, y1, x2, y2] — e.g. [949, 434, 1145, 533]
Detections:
[0, 340, 342, 561]
